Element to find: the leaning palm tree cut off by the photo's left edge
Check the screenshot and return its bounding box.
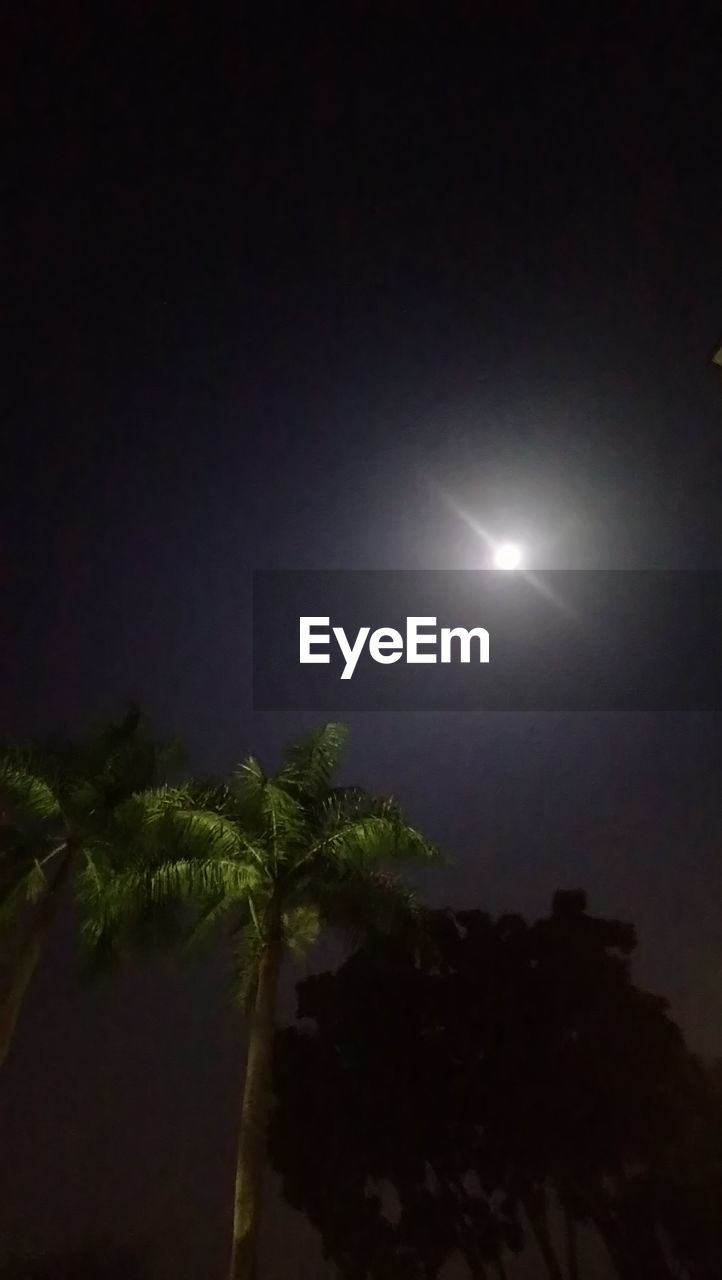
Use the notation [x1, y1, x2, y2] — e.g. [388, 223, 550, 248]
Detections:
[0, 709, 168, 1066]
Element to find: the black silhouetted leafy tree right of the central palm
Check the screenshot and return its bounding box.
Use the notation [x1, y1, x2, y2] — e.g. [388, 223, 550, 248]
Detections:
[271, 892, 721, 1280]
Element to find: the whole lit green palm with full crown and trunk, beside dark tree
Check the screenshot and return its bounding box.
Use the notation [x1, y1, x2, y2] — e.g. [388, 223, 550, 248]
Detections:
[83, 724, 435, 1280]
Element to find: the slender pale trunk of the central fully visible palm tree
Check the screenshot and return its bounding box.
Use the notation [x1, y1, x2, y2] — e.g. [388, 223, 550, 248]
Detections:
[229, 936, 283, 1280]
